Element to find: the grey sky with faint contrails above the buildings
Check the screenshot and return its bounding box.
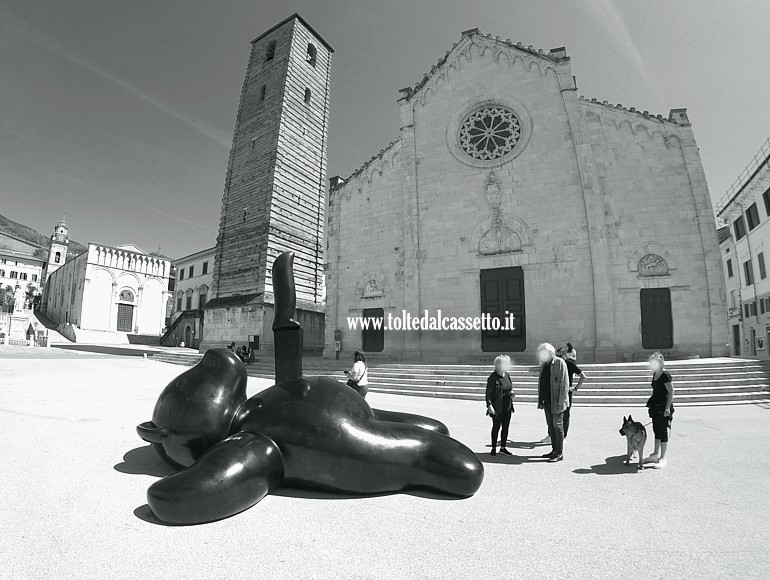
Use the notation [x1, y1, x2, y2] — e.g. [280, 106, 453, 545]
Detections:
[0, 0, 770, 258]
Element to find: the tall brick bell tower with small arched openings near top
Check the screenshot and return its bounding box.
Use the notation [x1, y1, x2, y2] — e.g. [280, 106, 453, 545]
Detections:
[200, 14, 334, 354]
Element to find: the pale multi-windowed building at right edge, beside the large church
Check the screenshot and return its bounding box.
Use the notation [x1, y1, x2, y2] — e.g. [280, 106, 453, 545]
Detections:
[716, 139, 770, 357]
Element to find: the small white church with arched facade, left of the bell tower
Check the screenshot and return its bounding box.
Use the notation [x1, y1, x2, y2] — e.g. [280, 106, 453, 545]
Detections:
[43, 244, 171, 340]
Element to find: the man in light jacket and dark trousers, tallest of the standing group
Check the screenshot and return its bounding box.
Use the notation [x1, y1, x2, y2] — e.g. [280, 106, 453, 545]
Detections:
[537, 342, 569, 463]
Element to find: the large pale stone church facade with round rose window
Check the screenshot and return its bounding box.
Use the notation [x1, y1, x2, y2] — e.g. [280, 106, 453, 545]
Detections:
[325, 29, 727, 362]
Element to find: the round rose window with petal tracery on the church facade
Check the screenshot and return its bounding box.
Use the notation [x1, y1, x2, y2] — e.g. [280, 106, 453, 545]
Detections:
[460, 106, 521, 161]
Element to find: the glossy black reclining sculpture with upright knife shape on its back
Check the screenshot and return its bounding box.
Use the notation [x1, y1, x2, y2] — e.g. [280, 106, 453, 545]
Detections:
[137, 252, 484, 524]
